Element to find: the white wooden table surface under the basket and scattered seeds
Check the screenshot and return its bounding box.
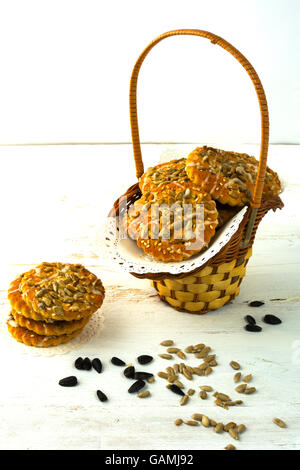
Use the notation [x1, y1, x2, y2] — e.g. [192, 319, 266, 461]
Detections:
[0, 145, 300, 450]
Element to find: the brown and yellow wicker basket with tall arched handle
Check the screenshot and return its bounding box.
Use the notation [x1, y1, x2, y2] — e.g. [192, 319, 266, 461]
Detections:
[112, 29, 283, 314]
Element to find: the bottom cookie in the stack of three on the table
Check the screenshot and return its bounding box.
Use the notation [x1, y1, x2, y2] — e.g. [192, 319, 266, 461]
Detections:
[7, 316, 82, 348]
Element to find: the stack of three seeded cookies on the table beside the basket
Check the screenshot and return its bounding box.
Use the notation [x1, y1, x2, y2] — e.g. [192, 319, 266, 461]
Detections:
[7, 263, 105, 347]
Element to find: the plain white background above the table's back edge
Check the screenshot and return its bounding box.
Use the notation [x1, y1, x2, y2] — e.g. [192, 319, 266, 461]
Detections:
[0, 0, 300, 145]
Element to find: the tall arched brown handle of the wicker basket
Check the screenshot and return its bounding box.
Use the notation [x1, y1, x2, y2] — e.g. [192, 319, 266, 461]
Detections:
[129, 29, 269, 213]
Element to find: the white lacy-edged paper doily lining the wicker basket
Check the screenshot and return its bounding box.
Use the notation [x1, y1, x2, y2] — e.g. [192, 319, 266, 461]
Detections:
[103, 206, 248, 274]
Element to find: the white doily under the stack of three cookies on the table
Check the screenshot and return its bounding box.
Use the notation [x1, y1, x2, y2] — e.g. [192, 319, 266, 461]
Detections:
[0, 309, 104, 356]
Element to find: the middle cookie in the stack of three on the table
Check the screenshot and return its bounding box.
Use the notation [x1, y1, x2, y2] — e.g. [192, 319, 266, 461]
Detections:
[11, 310, 90, 336]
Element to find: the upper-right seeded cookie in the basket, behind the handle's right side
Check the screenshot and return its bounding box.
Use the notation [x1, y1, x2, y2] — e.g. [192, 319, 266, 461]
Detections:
[186, 146, 281, 206]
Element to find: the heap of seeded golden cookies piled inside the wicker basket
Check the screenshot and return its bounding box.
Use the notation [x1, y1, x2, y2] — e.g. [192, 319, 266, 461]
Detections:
[122, 146, 281, 262]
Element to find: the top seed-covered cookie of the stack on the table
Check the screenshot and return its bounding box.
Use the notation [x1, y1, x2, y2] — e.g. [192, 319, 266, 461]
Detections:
[8, 263, 105, 321]
